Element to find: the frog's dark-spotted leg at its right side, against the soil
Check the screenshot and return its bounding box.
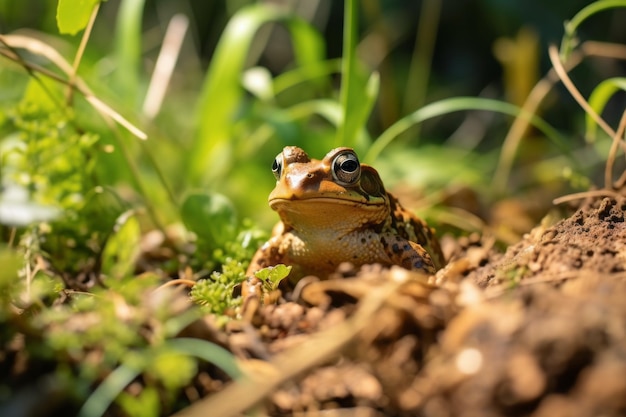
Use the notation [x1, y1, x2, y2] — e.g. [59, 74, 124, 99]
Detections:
[381, 235, 437, 274]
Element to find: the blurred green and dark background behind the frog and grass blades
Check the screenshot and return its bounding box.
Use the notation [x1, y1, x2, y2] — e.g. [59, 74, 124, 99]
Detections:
[0, 0, 626, 231]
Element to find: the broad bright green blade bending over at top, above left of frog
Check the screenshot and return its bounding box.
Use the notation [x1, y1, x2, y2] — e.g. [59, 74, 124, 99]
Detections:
[187, 4, 324, 185]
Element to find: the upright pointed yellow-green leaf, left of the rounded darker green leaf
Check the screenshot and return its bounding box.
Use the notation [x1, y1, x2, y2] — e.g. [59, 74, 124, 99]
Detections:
[102, 211, 141, 279]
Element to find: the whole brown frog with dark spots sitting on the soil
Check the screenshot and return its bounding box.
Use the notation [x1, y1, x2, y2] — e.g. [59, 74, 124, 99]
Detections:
[242, 146, 444, 297]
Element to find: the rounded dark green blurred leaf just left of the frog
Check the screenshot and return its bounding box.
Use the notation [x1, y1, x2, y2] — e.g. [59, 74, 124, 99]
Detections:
[181, 192, 237, 249]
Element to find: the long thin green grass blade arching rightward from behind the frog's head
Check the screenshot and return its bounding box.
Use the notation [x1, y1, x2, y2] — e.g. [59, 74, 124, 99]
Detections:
[363, 97, 569, 163]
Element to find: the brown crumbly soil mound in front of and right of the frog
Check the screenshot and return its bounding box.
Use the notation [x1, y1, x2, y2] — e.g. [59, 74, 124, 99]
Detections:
[191, 193, 626, 417]
